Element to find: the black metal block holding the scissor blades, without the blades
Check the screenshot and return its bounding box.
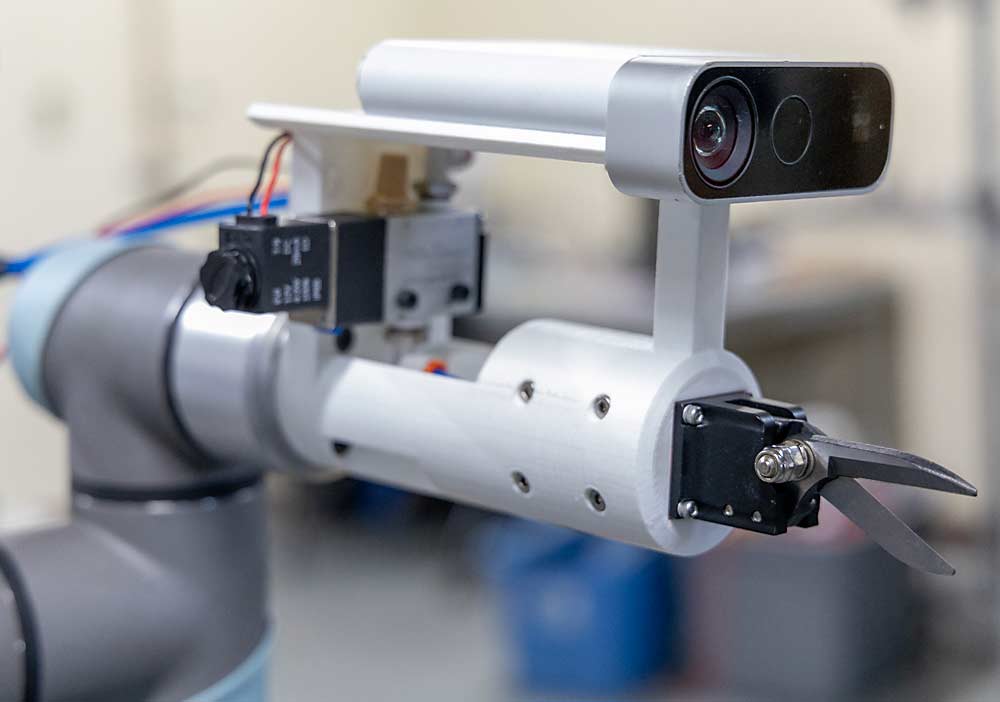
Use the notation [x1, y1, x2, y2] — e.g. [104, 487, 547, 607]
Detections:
[670, 394, 820, 535]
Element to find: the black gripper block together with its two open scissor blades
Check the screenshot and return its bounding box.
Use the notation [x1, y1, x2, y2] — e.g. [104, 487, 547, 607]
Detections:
[671, 395, 977, 575]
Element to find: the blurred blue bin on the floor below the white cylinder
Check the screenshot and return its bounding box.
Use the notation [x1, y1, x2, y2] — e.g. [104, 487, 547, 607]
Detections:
[478, 521, 681, 695]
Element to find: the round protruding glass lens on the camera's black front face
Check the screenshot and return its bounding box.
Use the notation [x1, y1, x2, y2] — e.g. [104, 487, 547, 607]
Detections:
[690, 78, 754, 186]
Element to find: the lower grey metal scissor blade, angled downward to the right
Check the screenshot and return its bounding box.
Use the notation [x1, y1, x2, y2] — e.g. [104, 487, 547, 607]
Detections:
[820, 478, 955, 575]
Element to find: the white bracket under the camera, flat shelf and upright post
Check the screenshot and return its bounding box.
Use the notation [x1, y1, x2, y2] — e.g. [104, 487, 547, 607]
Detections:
[250, 104, 729, 357]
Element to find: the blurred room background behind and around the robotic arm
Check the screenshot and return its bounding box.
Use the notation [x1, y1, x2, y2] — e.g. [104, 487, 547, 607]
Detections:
[0, 0, 1000, 700]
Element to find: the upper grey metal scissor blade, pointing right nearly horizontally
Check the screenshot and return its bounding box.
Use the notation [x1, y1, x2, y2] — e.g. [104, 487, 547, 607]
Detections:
[807, 435, 977, 497]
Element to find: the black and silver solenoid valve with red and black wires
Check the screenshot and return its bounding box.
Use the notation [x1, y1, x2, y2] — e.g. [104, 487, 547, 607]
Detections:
[201, 208, 485, 328]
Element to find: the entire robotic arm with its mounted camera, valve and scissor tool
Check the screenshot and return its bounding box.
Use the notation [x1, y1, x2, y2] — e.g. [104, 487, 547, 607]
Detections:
[0, 41, 976, 702]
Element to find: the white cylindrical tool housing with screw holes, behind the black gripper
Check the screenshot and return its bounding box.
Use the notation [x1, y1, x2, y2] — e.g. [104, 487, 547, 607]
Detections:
[308, 321, 757, 555]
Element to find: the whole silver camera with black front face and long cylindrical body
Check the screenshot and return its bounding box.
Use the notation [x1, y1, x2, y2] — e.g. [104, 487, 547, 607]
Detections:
[358, 40, 893, 202]
